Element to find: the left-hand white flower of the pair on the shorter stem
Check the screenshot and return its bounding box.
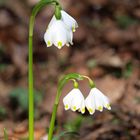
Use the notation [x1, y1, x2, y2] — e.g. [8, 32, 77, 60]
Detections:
[63, 88, 85, 113]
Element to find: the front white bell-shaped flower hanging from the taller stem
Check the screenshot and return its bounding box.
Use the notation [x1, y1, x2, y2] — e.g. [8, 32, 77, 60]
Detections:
[44, 20, 73, 49]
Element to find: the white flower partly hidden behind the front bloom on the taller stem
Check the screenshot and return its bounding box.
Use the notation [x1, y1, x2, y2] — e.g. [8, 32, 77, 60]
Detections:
[48, 10, 78, 32]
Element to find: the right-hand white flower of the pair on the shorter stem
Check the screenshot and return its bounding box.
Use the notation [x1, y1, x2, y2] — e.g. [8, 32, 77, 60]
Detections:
[85, 88, 111, 115]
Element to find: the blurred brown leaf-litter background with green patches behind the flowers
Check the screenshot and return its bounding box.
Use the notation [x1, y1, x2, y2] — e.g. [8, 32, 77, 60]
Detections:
[0, 0, 140, 140]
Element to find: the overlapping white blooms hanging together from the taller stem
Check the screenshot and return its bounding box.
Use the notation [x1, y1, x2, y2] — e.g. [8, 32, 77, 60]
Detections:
[44, 10, 78, 49]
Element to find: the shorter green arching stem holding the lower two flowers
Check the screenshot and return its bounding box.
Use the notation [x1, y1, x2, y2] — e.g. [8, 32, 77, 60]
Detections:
[48, 73, 83, 140]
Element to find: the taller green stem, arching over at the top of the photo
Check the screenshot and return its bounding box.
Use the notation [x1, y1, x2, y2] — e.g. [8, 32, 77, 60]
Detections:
[28, 0, 59, 140]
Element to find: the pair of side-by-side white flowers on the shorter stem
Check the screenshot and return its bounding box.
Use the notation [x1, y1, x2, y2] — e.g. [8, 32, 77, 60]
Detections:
[63, 87, 111, 115]
